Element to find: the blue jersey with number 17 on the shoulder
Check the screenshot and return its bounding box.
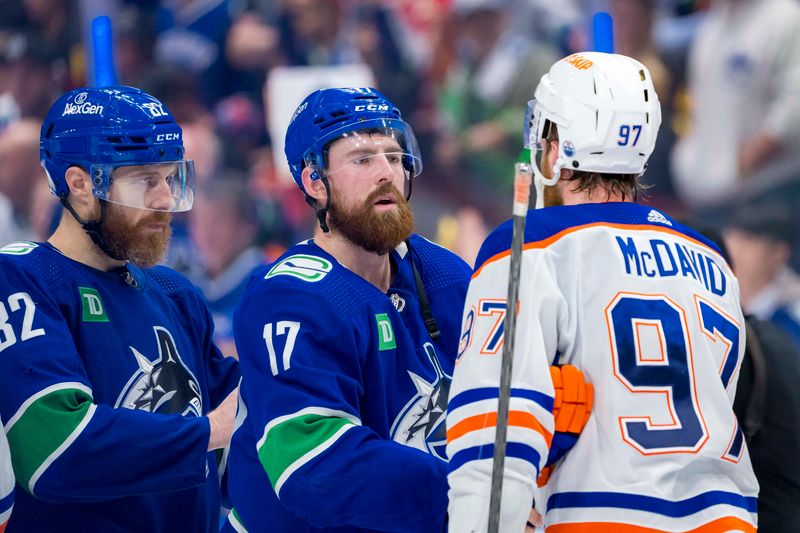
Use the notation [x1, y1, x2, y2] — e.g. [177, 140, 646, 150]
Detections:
[227, 236, 471, 533]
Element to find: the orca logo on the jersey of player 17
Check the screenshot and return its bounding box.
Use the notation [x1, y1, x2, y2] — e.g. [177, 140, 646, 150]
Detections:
[389, 342, 453, 460]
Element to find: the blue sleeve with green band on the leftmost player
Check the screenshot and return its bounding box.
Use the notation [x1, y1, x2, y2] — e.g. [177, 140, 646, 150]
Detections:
[0, 265, 210, 503]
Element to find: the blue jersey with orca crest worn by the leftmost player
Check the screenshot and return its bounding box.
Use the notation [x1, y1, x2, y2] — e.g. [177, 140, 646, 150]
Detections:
[0, 242, 239, 532]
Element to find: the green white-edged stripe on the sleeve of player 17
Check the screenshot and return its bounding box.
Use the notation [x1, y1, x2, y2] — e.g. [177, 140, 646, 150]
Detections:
[258, 413, 355, 496]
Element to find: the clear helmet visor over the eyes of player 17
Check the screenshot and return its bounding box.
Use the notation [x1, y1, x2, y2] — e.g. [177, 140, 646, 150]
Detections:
[306, 121, 422, 177]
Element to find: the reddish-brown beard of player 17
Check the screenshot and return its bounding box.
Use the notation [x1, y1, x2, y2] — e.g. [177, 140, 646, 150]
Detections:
[328, 182, 414, 254]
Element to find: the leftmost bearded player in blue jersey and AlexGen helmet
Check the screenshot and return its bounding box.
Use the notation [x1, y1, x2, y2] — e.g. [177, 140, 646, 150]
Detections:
[0, 86, 239, 532]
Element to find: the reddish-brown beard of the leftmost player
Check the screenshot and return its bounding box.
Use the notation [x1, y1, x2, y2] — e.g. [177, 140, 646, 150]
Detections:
[92, 202, 172, 267]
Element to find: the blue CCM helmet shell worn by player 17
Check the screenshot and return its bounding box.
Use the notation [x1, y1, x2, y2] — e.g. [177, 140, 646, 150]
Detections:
[285, 87, 422, 189]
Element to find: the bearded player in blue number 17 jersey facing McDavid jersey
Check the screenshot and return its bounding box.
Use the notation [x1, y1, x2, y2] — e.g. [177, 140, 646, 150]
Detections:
[226, 89, 471, 533]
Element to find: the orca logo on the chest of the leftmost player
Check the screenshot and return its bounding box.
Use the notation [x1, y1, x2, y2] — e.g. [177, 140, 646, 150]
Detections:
[114, 326, 203, 417]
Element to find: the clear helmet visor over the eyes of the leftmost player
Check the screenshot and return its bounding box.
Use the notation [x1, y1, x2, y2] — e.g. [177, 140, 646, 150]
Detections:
[89, 161, 194, 212]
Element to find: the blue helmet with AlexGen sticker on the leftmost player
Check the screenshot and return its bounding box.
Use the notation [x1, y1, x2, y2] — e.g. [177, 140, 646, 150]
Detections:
[40, 86, 194, 211]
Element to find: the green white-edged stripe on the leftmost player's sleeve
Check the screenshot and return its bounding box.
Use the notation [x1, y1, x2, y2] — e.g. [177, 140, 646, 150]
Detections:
[7, 386, 94, 494]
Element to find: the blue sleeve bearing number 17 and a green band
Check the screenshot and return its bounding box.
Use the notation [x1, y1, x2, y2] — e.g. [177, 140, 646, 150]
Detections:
[235, 286, 447, 532]
